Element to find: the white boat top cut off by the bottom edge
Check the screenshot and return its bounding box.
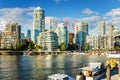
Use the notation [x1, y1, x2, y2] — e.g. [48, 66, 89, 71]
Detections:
[48, 73, 74, 80]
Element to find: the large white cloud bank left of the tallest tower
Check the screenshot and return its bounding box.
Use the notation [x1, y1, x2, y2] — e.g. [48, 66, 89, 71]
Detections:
[0, 7, 34, 32]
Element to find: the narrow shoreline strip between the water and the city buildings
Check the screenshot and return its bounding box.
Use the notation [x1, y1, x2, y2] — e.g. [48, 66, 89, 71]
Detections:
[0, 50, 119, 55]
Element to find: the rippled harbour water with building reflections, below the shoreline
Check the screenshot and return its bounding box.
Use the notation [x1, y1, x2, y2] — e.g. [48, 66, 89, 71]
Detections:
[0, 55, 107, 80]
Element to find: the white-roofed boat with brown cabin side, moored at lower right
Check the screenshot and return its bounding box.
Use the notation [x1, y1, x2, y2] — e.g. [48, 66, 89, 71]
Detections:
[80, 62, 106, 80]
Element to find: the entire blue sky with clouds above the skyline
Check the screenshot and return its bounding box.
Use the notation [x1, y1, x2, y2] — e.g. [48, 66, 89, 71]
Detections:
[0, 0, 120, 34]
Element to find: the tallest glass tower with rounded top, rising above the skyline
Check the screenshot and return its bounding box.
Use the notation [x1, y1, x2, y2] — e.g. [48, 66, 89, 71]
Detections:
[33, 7, 45, 44]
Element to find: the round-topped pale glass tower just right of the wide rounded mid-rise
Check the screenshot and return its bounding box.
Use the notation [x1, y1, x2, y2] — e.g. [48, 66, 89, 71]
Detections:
[56, 23, 68, 46]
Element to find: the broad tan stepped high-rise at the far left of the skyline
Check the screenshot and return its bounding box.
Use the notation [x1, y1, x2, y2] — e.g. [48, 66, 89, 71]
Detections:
[1, 22, 21, 49]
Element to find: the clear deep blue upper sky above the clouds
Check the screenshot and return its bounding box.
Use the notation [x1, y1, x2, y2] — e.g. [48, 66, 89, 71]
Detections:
[0, 0, 120, 17]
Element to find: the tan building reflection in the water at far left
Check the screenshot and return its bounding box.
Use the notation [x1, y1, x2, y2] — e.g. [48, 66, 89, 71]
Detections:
[0, 55, 19, 80]
